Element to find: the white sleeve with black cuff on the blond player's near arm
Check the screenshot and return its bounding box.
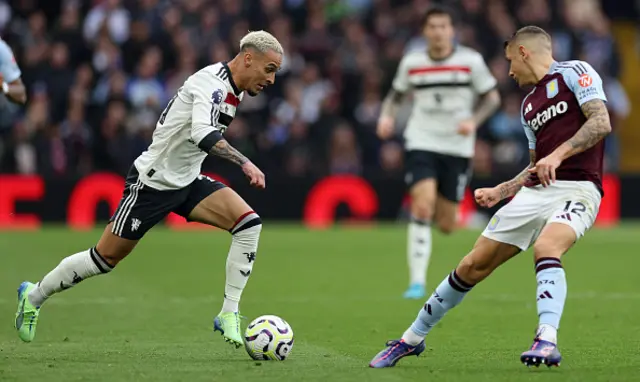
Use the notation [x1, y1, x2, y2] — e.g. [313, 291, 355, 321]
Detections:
[188, 74, 227, 152]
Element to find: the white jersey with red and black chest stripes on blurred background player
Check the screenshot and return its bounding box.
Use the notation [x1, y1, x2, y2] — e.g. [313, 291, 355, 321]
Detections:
[393, 46, 497, 158]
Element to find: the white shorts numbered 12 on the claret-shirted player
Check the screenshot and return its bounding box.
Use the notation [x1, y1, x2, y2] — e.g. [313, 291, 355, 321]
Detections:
[482, 181, 602, 251]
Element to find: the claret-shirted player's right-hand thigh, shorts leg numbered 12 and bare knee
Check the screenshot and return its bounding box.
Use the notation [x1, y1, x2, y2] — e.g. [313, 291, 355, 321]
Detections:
[534, 182, 601, 260]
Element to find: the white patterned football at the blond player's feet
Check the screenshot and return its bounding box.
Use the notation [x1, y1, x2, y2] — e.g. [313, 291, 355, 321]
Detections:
[244, 315, 293, 361]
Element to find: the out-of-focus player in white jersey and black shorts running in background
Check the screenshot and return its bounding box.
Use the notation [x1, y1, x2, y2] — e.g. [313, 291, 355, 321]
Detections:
[378, 7, 500, 299]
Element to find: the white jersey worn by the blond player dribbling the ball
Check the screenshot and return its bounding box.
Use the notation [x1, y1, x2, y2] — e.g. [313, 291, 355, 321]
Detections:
[134, 63, 243, 190]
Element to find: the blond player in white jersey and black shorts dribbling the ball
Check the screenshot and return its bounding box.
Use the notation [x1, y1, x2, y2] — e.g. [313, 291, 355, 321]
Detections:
[15, 31, 283, 347]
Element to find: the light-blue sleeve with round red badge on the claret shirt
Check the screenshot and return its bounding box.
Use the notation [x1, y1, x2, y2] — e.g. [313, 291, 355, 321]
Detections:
[562, 61, 607, 106]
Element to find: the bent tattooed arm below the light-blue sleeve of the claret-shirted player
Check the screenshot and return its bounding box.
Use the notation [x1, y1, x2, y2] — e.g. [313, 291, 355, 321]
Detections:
[554, 99, 611, 160]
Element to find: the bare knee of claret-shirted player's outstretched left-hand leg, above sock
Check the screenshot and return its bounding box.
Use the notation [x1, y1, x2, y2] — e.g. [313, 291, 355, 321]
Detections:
[456, 236, 521, 284]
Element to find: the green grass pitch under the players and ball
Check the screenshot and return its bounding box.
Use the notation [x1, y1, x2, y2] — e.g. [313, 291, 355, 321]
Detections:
[0, 223, 640, 382]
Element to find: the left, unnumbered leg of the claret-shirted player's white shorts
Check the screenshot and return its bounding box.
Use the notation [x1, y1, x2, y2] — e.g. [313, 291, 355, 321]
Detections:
[482, 188, 546, 251]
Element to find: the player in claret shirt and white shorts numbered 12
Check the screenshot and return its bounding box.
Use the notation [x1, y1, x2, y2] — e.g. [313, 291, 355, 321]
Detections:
[370, 26, 611, 368]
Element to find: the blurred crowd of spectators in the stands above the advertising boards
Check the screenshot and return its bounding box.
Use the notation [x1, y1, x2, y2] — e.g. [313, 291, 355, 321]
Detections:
[0, 0, 631, 178]
